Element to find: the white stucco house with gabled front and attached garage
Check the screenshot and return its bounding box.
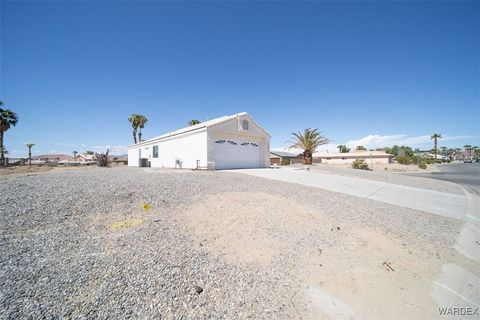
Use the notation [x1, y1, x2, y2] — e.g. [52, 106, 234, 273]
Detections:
[128, 112, 270, 169]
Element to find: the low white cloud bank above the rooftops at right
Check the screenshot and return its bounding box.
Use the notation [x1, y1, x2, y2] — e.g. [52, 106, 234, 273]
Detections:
[345, 134, 472, 148]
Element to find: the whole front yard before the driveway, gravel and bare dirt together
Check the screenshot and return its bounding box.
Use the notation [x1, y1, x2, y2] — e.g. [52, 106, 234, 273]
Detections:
[0, 168, 468, 319]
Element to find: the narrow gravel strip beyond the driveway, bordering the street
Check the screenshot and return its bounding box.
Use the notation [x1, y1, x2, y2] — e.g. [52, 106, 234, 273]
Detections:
[311, 164, 464, 195]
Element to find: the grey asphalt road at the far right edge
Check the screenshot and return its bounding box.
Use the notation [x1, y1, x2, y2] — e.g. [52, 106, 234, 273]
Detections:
[411, 163, 480, 195]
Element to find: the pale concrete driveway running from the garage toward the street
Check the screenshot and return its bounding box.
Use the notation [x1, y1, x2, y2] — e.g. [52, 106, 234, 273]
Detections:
[230, 168, 466, 220]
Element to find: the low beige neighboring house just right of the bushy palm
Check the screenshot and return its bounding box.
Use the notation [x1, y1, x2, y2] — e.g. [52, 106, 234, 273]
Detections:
[313, 151, 393, 164]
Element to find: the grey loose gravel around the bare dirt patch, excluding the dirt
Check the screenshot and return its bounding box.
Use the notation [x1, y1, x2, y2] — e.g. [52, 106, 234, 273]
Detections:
[0, 168, 461, 319]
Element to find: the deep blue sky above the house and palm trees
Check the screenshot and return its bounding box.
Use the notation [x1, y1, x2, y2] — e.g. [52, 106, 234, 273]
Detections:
[0, 1, 480, 156]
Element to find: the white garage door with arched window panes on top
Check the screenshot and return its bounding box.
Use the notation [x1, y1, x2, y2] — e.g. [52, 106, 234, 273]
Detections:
[213, 139, 261, 169]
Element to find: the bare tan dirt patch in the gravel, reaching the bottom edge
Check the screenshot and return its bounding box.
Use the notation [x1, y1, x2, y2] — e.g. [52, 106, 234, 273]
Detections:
[182, 192, 452, 319]
